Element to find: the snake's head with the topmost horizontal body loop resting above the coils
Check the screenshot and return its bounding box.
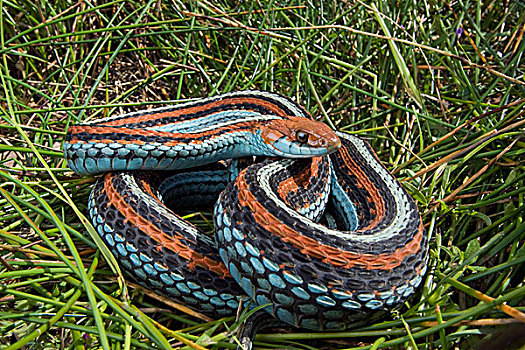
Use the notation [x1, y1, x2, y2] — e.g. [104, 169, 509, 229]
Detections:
[64, 91, 340, 175]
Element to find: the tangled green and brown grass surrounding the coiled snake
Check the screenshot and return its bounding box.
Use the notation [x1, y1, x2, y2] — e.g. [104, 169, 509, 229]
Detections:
[0, 0, 525, 350]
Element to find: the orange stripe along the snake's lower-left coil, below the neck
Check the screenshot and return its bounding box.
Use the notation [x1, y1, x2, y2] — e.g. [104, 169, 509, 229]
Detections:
[104, 173, 231, 278]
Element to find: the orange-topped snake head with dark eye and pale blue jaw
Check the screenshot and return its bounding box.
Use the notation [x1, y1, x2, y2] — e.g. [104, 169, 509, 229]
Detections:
[261, 117, 341, 158]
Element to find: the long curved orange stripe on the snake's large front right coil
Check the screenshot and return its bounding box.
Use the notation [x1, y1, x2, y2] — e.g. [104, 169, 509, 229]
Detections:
[235, 171, 424, 270]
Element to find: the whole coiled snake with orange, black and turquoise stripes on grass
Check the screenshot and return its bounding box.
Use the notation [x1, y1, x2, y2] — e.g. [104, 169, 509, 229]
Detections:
[64, 91, 429, 338]
